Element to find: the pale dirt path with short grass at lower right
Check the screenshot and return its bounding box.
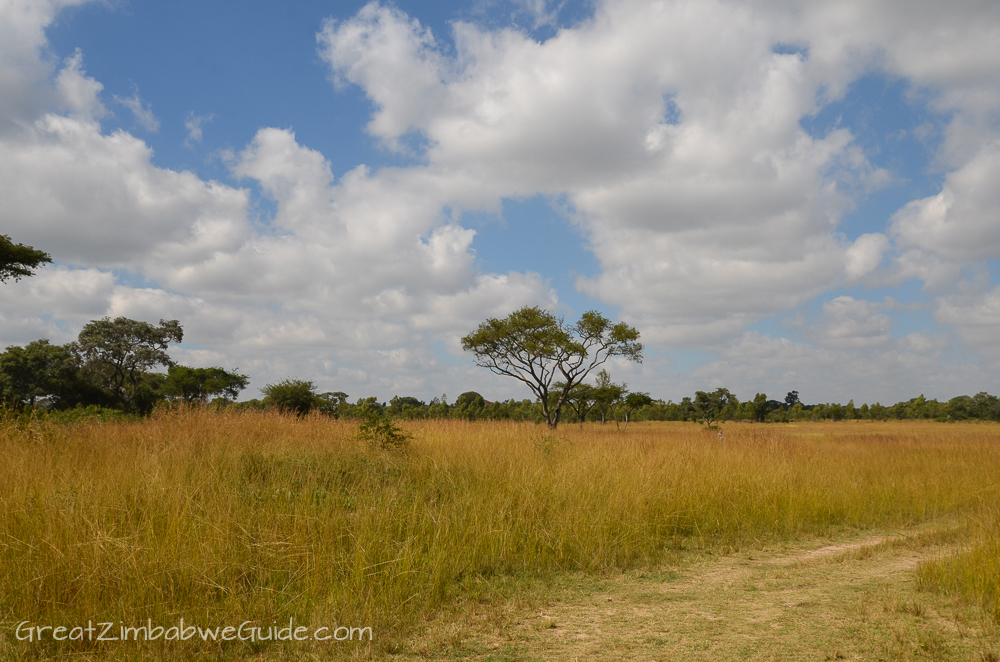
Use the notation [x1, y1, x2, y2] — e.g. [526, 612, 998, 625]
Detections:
[411, 528, 1000, 662]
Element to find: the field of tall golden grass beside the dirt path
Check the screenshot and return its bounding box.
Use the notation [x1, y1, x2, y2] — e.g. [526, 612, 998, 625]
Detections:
[0, 408, 1000, 660]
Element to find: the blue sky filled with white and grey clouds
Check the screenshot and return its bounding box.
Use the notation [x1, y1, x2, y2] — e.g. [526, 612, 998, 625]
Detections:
[0, 0, 1000, 404]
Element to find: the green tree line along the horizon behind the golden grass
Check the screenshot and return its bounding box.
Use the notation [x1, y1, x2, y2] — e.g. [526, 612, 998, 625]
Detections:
[0, 310, 1000, 429]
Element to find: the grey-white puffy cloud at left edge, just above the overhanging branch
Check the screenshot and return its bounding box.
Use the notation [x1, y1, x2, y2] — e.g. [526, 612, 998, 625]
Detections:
[0, 114, 247, 271]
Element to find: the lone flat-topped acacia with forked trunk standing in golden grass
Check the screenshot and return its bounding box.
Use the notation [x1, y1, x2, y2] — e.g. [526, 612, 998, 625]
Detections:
[462, 306, 642, 428]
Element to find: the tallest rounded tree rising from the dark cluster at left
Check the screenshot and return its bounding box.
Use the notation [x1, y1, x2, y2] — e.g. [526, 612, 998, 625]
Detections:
[70, 317, 184, 412]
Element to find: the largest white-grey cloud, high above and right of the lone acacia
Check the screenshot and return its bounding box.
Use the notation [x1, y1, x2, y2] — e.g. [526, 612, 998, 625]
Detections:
[320, 2, 904, 343]
